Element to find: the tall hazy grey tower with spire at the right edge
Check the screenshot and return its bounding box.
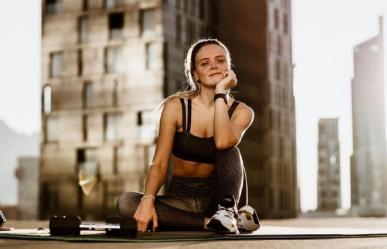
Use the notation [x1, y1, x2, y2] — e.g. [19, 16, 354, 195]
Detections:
[351, 17, 387, 216]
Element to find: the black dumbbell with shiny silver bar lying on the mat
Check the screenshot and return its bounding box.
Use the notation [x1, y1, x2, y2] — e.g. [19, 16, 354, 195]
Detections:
[49, 216, 137, 238]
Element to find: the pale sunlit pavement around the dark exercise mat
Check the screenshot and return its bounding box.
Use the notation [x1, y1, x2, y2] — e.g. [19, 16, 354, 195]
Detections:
[0, 218, 387, 249]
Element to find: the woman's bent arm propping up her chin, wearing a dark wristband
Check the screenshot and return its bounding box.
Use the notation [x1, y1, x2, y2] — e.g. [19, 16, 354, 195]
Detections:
[214, 71, 254, 150]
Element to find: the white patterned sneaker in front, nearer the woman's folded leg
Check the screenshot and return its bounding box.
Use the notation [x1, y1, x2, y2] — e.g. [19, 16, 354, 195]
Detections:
[207, 195, 239, 234]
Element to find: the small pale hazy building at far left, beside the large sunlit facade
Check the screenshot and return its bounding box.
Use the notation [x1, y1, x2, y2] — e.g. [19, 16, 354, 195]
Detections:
[15, 157, 39, 220]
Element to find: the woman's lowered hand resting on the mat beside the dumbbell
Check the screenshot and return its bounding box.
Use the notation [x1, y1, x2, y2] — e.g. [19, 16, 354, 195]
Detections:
[133, 198, 158, 232]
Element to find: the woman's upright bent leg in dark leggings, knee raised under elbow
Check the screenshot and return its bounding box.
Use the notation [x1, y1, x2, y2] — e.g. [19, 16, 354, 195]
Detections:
[205, 147, 247, 217]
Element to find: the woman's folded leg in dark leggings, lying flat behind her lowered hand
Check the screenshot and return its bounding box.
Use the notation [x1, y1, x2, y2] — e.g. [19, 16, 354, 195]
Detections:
[116, 192, 204, 230]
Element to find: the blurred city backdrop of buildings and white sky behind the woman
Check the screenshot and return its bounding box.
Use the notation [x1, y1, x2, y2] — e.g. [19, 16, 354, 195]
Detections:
[0, 0, 387, 222]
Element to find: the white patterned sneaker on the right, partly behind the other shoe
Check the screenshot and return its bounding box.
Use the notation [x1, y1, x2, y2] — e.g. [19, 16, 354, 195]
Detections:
[238, 205, 260, 232]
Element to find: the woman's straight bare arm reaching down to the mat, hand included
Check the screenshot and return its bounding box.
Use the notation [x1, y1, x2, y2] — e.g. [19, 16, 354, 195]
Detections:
[133, 99, 179, 232]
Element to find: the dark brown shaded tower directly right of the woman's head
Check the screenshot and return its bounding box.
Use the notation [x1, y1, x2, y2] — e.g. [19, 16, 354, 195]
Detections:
[214, 0, 299, 218]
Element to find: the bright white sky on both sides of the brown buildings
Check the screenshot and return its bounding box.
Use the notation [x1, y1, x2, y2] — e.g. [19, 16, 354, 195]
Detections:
[0, 0, 387, 211]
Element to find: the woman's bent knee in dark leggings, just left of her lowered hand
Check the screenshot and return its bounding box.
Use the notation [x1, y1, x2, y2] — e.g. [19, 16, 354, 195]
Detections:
[116, 192, 142, 217]
